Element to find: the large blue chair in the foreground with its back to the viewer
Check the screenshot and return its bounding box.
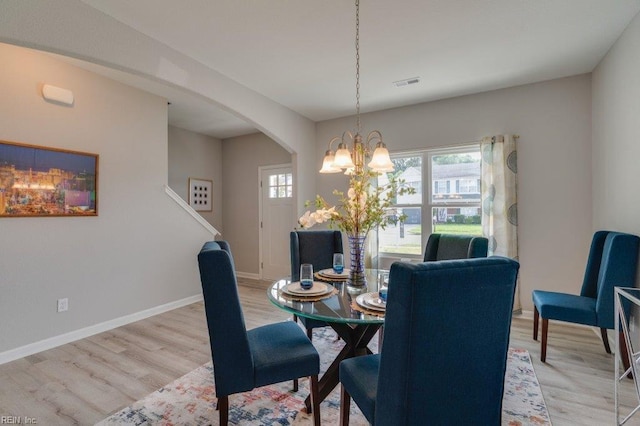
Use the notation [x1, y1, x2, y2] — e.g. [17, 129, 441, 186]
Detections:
[340, 257, 520, 426]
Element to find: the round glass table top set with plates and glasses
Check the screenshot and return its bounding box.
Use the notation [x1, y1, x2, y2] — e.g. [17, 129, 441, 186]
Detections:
[267, 269, 389, 324]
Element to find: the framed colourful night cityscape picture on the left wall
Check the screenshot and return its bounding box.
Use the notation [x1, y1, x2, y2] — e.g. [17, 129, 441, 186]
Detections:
[0, 141, 98, 217]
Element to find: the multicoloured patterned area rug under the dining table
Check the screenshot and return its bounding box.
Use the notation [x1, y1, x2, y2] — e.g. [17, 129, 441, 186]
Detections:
[98, 328, 551, 426]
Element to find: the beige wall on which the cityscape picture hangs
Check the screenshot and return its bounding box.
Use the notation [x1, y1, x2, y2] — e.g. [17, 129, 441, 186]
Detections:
[0, 44, 211, 358]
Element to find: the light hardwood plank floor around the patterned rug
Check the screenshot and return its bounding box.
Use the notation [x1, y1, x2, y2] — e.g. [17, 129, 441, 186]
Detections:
[0, 280, 640, 426]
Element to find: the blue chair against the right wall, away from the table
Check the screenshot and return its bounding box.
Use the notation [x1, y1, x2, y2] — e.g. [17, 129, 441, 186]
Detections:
[532, 231, 640, 362]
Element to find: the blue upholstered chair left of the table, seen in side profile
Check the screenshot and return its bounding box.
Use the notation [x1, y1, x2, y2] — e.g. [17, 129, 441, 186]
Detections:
[198, 241, 320, 425]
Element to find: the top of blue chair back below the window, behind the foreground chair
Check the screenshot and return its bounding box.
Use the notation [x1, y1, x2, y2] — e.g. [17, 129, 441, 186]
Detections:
[424, 234, 489, 262]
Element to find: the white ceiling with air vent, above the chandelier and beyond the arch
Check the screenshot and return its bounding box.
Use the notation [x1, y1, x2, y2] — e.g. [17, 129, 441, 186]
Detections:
[82, 0, 640, 138]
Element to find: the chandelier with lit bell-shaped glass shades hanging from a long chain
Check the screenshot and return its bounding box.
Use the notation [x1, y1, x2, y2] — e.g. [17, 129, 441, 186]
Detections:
[320, 0, 393, 175]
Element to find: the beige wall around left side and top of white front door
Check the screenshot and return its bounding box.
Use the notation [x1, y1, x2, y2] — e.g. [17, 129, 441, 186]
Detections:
[222, 133, 295, 276]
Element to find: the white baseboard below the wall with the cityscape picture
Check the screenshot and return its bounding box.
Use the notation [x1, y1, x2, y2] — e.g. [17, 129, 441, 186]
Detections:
[0, 294, 202, 365]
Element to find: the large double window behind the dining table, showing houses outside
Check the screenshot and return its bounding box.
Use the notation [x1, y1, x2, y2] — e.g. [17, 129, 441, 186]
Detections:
[378, 145, 482, 258]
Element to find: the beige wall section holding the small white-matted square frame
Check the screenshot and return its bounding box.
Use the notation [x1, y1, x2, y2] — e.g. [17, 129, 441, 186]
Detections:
[169, 126, 224, 233]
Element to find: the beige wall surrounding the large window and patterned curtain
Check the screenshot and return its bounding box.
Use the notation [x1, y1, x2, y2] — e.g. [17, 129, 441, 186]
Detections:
[316, 75, 592, 310]
